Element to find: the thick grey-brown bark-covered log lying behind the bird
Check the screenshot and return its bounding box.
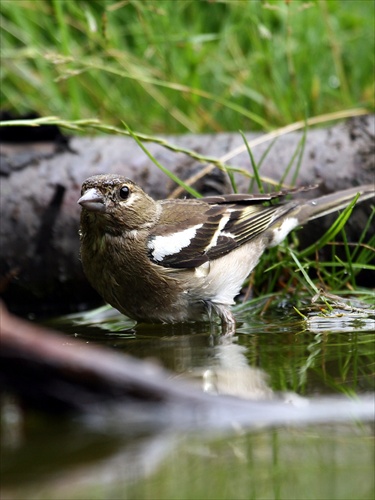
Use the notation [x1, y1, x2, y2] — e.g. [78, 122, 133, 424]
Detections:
[0, 116, 375, 312]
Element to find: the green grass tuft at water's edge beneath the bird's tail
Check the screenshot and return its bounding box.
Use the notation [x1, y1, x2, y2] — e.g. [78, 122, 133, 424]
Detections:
[251, 202, 375, 300]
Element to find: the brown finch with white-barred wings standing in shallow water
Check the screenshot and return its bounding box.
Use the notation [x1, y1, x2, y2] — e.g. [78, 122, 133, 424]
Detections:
[78, 174, 374, 334]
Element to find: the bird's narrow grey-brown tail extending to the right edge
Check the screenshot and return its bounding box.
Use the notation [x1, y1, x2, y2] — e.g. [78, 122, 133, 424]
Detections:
[293, 184, 375, 224]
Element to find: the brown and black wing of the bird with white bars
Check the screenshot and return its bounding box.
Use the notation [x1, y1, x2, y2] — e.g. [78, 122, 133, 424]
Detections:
[148, 199, 288, 268]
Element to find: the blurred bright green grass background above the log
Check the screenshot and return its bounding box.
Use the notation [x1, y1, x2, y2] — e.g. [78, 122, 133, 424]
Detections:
[0, 0, 375, 134]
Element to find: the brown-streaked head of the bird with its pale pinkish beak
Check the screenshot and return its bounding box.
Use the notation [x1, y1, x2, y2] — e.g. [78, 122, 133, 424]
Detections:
[78, 174, 158, 231]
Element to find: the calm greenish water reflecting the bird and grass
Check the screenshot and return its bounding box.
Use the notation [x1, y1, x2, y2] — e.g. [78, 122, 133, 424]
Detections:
[1, 303, 375, 500]
